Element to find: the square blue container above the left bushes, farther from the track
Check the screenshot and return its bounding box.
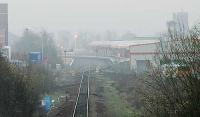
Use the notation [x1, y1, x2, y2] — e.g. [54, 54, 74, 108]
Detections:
[29, 52, 42, 63]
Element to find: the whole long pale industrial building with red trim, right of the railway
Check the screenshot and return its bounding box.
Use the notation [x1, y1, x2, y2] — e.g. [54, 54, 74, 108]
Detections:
[89, 38, 159, 72]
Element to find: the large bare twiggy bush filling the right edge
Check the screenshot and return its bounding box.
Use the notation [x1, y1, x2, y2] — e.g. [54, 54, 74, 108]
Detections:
[139, 26, 200, 117]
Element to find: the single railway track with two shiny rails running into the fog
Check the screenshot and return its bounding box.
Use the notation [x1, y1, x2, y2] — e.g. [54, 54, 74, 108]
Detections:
[72, 72, 90, 117]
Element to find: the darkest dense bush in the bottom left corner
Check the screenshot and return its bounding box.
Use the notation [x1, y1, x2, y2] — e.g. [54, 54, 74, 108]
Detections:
[0, 56, 39, 117]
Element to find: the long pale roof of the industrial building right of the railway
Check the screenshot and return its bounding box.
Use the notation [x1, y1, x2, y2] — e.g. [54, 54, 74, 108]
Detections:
[89, 40, 159, 49]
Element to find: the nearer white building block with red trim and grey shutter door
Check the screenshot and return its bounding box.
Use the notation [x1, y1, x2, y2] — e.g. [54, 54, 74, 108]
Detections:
[130, 40, 159, 72]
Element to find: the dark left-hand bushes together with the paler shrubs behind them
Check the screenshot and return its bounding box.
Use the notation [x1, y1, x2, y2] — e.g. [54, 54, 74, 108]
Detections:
[0, 56, 55, 117]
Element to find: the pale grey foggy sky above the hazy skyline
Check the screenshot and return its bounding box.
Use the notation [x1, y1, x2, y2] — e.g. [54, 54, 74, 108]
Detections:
[0, 0, 200, 36]
